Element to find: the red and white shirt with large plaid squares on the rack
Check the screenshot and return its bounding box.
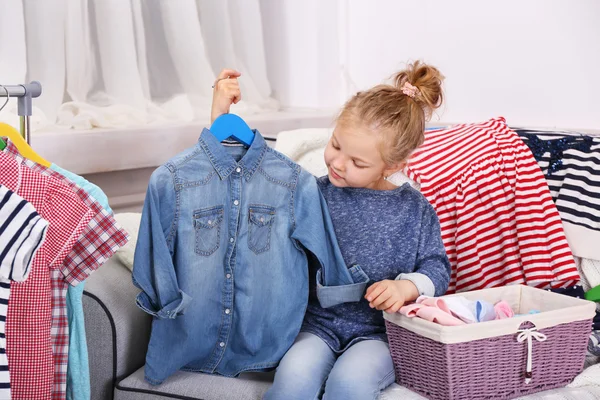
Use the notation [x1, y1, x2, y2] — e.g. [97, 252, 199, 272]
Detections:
[7, 143, 129, 400]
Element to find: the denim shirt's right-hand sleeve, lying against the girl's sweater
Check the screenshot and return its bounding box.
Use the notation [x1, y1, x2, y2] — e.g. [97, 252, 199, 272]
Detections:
[292, 170, 369, 307]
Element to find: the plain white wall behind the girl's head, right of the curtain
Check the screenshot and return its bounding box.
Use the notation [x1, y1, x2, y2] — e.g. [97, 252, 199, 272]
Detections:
[261, 0, 600, 129]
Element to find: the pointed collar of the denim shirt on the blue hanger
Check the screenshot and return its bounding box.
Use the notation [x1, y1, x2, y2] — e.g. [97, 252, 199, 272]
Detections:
[198, 128, 267, 181]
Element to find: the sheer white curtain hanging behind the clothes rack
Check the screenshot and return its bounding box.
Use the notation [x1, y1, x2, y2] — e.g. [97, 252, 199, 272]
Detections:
[0, 0, 278, 129]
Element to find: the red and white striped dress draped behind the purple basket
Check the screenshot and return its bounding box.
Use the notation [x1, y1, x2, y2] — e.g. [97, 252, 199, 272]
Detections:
[405, 118, 580, 293]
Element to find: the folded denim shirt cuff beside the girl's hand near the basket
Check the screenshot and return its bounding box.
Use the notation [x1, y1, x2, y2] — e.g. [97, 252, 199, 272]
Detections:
[317, 265, 369, 308]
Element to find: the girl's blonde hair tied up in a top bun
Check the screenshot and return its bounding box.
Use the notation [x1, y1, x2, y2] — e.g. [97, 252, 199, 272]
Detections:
[338, 61, 444, 165]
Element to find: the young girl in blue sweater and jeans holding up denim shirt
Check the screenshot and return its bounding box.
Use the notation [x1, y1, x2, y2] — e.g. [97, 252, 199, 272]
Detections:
[213, 62, 450, 400]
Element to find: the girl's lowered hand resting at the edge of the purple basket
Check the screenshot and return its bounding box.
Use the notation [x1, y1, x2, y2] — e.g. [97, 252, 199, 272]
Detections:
[365, 279, 419, 314]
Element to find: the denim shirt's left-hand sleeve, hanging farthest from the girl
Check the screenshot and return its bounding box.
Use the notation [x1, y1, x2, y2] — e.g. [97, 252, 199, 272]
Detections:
[133, 166, 191, 319]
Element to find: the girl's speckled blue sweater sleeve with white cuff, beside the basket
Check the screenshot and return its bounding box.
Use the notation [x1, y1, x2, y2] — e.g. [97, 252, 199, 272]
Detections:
[412, 203, 450, 296]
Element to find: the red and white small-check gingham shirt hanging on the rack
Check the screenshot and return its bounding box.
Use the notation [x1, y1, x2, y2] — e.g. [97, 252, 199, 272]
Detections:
[0, 145, 94, 400]
